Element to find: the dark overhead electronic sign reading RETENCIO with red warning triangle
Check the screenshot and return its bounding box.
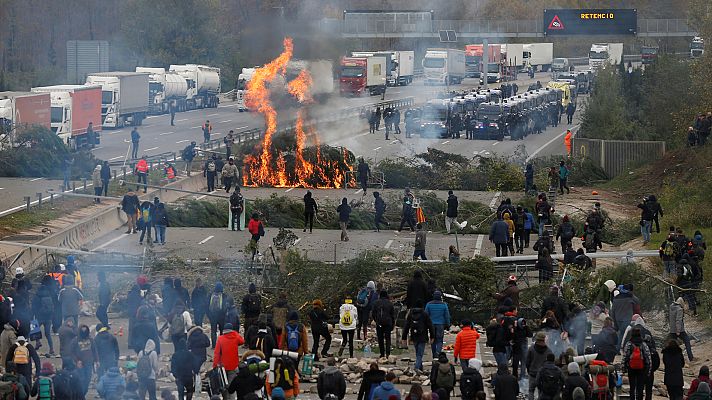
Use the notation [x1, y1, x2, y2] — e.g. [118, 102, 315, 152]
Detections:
[544, 8, 638, 36]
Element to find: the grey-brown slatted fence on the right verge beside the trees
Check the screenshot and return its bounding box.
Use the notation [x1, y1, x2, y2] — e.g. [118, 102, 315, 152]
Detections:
[572, 137, 665, 178]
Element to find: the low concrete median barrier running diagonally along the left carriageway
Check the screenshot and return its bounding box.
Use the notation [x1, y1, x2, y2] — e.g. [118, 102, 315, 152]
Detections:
[9, 174, 205, 272]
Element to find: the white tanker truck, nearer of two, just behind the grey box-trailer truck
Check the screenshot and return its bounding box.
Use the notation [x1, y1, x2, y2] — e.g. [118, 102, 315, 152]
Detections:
[136, 67, 188, 114]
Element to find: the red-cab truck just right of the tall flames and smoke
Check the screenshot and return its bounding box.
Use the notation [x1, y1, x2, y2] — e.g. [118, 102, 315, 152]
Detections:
[339, 56, 388, 96]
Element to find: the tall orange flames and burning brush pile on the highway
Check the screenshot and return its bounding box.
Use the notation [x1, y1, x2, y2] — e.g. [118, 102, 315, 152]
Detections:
[242, 38, 354, 188]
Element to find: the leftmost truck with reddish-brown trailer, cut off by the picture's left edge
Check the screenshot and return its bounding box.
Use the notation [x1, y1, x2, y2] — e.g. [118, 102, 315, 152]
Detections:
[0, 92, 51, 139]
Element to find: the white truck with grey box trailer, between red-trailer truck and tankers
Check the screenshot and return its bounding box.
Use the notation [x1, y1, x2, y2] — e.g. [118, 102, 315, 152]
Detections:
[86, 71, 149, 128]
